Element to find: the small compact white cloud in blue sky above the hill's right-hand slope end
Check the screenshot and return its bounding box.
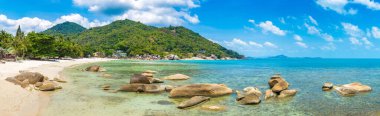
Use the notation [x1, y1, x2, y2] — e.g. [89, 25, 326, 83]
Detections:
[258, 21, 286, 36]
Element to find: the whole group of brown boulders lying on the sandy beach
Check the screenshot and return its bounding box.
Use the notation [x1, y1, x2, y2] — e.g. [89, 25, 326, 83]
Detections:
[5, 71, 66, 91]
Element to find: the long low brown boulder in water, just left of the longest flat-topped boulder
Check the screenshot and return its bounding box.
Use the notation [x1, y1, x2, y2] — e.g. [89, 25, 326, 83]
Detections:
[119, 84, 167, 93]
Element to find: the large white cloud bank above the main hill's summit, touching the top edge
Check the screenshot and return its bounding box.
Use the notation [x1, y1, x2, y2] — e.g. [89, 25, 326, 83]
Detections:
[74, 0, 200, 26]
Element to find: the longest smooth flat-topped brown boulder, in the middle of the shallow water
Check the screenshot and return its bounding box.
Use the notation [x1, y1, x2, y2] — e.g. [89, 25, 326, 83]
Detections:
[169, 84, 232, 97]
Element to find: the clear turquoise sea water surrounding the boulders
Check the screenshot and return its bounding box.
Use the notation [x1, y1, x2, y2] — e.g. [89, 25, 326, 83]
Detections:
[41, 59, 380, 116]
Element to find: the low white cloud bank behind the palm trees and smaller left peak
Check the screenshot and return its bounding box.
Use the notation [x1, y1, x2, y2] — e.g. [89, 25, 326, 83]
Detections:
[0, 14, 109, 33]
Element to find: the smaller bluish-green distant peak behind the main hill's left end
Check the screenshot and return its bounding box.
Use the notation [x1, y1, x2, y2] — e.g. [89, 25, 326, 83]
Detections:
[41, 22, 86, 37]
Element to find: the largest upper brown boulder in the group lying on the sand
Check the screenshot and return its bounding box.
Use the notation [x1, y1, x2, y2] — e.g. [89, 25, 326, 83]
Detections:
[14, 72, 45, 84]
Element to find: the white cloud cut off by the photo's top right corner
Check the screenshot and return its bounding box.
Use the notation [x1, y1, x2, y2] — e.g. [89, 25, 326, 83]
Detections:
[316, 0, 380, 15]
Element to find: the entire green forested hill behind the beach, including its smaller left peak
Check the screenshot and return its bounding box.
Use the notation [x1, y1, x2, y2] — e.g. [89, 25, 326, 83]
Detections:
[43, 20, 243, 58]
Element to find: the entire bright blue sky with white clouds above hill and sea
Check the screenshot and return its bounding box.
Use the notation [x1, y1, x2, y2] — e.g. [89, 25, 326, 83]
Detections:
[0, 0, 380, 58]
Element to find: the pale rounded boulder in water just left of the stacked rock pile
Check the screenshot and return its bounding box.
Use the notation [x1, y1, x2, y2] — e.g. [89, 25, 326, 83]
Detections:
[236, 87, 262, 105]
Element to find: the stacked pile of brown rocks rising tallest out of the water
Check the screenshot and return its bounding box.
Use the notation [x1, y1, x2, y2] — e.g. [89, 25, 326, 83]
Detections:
[265, 74, 297, 99]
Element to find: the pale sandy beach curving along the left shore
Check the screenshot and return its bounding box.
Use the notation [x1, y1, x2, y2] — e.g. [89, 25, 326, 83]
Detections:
[0, 58, 112, 116]
